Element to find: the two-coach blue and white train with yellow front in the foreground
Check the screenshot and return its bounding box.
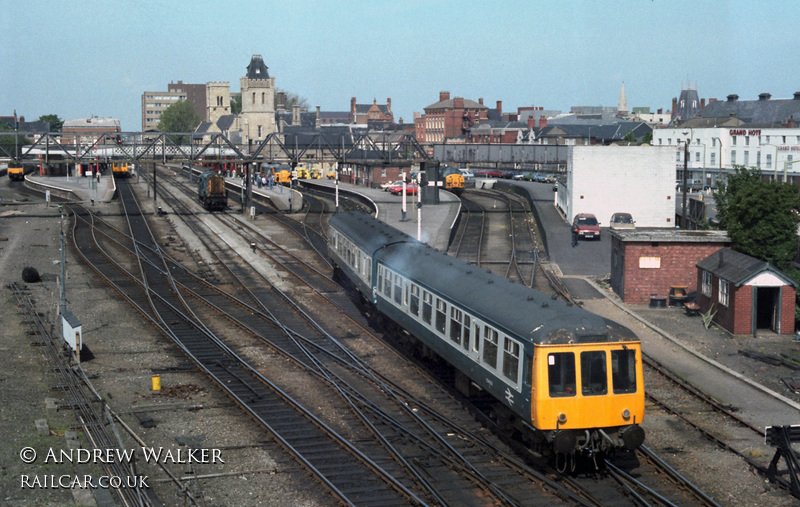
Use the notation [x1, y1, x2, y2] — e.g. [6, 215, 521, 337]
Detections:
[328, 212, 644, 463]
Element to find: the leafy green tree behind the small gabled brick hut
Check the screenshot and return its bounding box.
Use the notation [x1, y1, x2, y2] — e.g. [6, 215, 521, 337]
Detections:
[714, 166, 800, 269]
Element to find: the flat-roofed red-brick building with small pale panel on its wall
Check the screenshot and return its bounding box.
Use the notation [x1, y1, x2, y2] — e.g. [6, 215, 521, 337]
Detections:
[611, 229, 730, 305]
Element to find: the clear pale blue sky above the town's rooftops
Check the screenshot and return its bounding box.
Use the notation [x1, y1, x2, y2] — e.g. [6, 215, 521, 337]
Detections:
[0, 0, 800, 132]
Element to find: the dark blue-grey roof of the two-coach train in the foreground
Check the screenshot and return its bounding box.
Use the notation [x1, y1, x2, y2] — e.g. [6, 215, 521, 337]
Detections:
[332, 212, 638, 343]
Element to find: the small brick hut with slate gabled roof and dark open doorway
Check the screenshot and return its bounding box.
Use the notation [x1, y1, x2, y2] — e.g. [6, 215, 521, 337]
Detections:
[697, 248, 797, 336]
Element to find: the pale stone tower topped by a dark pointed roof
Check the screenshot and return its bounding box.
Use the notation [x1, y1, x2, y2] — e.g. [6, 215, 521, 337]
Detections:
[240, 55, 276, 149]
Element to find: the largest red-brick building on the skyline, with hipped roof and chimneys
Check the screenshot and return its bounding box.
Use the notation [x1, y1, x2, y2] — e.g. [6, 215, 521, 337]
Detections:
[414, 92, 489, 144]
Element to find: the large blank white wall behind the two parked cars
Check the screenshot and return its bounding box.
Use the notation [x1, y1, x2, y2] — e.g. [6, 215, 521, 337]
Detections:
[565, 146, 675, 227]
